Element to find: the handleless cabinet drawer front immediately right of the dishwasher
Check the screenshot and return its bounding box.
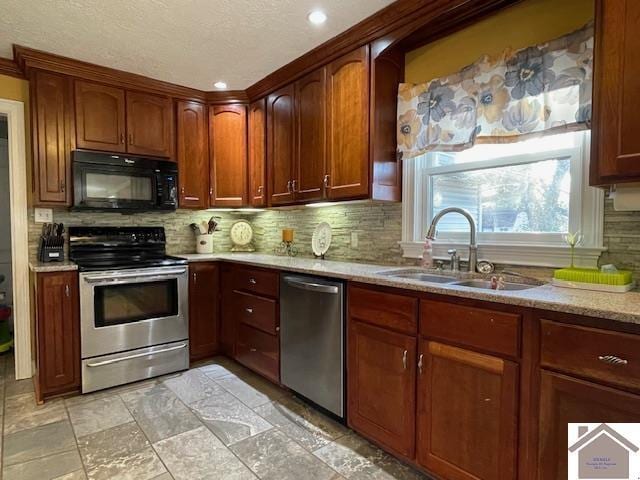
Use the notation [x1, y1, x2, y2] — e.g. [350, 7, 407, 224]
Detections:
[348, 286, 418, 335]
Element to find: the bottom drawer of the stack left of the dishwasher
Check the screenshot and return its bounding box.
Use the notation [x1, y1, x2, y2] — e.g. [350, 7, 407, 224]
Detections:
[236, 324, 280, 383]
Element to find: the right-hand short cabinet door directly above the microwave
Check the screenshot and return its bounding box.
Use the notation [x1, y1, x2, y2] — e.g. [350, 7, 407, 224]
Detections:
[127, 92, 173, 158]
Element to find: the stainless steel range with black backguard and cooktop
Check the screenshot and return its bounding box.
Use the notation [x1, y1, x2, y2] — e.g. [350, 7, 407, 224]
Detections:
[69, 227, 189, 393]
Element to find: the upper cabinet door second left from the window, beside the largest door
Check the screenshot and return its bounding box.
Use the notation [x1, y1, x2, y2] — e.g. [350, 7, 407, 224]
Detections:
[293, 68, 327, 201]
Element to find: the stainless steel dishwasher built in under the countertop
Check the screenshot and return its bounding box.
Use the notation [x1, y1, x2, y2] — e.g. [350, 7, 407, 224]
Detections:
[280, 273, 345, 418]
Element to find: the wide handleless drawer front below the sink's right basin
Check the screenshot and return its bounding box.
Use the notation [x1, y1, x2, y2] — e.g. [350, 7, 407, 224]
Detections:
[420, 300, 520, 357]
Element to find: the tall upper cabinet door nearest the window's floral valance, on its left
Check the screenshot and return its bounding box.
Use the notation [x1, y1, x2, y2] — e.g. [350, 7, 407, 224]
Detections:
[327, 46, 369, 199]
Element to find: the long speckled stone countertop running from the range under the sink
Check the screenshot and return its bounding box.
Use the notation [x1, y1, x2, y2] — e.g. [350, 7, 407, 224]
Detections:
[178, 253, 640, 325]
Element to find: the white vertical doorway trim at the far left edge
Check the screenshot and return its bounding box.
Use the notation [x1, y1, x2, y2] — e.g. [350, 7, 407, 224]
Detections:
[0, 99, 33, 380]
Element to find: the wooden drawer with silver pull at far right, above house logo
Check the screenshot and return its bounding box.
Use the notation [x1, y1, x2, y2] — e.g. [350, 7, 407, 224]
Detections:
[541, 320, 640, 390]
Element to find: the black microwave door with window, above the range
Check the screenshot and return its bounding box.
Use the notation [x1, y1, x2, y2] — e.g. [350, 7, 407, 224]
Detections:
[73, 162, 158, 211]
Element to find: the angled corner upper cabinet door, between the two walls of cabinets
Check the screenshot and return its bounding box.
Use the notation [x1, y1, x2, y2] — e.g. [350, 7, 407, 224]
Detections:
[209, 105, 247, 207]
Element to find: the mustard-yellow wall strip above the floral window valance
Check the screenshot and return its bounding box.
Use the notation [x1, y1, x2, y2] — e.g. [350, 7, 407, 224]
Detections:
[405, 0, 594, 83]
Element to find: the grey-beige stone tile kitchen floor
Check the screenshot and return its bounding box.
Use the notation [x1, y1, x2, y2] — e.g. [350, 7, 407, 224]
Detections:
[0, 355, 426, 480]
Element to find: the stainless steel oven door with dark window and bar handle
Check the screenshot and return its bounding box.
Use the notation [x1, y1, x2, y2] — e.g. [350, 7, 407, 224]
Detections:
[80, 267, 189, 359]
